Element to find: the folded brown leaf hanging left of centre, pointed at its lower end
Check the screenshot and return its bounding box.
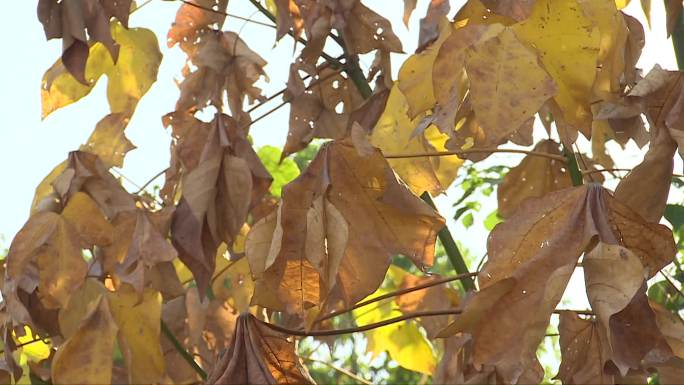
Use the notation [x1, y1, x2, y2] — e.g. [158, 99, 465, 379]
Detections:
[171, 114, 271, 295]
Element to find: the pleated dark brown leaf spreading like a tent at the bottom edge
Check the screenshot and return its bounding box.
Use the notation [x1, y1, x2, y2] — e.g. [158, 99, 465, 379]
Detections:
[207, 313, 314, 385]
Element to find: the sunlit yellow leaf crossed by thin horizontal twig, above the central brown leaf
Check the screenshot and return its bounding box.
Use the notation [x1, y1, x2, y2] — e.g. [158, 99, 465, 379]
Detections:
[371, 86, 463, 195]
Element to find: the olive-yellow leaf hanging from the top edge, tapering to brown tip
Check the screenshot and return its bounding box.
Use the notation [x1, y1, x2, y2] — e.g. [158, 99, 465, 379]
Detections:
[511, 0, 601, 136]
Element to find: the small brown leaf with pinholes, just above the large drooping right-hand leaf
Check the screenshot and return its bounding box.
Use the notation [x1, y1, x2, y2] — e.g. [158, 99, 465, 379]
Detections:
[497, 140, 572, 218]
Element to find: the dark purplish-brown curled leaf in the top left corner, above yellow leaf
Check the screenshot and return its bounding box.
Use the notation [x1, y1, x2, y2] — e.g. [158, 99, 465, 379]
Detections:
[38, 0, 132, 84]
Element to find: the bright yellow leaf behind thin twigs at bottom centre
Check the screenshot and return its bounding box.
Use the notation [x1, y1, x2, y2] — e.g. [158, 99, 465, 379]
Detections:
[354, 265, 437, 374]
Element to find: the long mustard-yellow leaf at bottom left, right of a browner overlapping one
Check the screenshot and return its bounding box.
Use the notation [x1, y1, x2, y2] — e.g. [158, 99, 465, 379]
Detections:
[107, 285, 164, 384]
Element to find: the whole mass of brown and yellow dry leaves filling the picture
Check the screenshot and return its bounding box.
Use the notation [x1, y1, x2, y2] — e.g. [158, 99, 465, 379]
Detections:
[0, 0, 684, 384]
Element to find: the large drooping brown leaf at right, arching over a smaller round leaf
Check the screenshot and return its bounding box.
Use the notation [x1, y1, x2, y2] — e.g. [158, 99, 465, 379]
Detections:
[440, 184, 675, 383]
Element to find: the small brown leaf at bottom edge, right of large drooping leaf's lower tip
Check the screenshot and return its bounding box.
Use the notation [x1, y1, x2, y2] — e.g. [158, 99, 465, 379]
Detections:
[555, 311, 614, 385]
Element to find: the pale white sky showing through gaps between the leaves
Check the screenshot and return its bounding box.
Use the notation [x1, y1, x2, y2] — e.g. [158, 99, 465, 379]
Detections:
[0, 0, 681, 255]
